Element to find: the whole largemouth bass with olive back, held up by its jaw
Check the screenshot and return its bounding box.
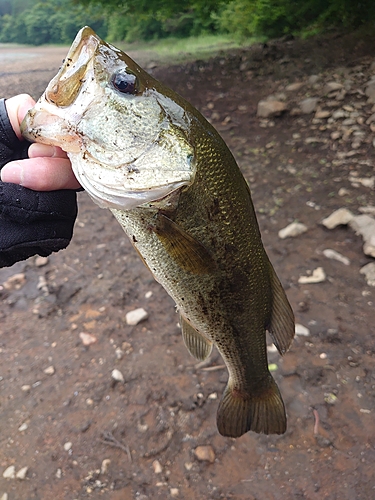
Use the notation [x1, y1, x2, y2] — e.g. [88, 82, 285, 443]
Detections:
[21, 26, 295, 437]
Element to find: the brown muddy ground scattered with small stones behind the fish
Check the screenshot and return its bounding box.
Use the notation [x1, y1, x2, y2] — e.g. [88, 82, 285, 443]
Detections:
[0, 35, 375, 500]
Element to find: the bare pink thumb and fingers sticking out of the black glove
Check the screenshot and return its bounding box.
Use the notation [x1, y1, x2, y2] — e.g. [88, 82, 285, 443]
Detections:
[0, 94, 80, 191]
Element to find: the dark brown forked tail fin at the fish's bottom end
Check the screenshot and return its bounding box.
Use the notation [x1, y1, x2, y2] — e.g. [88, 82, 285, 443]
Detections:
[217, 374, 286, 437]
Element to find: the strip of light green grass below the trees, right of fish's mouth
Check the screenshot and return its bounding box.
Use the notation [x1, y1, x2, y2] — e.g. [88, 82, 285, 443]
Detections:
[113, 35, 255, 64]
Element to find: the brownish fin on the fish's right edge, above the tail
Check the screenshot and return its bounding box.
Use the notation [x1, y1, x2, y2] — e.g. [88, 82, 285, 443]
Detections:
[267, 264, 295, 354]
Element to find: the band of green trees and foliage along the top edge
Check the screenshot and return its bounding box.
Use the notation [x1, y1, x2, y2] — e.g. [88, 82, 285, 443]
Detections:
[0, 0, 375, 44]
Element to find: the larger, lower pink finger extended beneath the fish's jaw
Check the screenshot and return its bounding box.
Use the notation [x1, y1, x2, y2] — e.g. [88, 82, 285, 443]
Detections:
[1, 157, 80, 191]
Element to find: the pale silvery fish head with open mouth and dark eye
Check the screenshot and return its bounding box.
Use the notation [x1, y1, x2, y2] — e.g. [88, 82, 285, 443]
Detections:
[21, 27, 196, 210]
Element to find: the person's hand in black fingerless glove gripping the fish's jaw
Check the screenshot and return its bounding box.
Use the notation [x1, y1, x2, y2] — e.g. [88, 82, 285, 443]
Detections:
[0, 94, 79, 267]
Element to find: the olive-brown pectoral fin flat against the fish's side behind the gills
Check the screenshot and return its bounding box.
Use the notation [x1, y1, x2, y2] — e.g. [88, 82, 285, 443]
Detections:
[155, 214, 215, 274]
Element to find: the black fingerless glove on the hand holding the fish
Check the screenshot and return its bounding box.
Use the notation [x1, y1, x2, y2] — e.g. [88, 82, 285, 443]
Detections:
[0, 99, 77, 267]
